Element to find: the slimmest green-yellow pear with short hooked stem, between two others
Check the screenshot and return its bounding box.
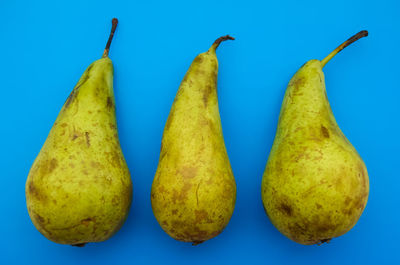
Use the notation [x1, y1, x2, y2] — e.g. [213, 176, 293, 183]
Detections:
[151, 35, 236, 245]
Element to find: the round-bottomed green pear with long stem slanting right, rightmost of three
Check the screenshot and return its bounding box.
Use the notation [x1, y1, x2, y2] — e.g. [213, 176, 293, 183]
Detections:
[262, 31, 369, 245]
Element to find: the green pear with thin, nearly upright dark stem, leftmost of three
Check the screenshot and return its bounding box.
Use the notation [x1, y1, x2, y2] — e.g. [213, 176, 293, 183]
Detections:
[25, 19, 132, 246]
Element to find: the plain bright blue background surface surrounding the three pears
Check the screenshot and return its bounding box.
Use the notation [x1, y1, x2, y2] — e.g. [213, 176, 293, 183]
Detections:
[0, 0, 400, 264]
